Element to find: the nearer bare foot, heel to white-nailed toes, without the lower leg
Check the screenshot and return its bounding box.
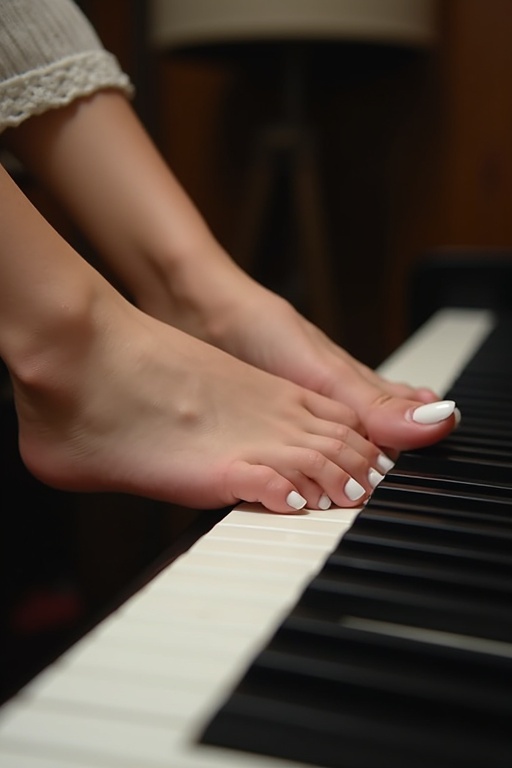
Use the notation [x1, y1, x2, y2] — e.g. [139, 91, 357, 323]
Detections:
[13, 288, 388, 512]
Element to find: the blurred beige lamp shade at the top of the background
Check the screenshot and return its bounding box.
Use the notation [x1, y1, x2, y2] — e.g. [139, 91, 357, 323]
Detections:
[150, 0, 436, 48]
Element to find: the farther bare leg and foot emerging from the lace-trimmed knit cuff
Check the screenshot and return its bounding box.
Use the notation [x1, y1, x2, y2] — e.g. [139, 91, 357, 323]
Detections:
[4, 92, 455, 450]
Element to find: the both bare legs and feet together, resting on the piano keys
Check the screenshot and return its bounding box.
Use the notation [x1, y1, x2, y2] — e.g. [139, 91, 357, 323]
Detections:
[0, 91, 454, 512]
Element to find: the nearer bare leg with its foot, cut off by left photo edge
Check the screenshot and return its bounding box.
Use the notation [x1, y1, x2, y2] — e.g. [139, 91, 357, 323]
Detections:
[0, 163, 388, 512]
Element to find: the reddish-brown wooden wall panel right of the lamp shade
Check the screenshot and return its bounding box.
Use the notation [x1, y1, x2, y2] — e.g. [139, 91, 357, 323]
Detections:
[442, 0, 512, 246]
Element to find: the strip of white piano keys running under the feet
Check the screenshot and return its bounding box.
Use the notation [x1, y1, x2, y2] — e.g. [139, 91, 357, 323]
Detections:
[0, 310, 494, 768]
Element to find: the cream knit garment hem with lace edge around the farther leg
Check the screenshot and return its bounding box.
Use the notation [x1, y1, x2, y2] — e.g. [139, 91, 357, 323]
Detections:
[0, 0, 133, 131]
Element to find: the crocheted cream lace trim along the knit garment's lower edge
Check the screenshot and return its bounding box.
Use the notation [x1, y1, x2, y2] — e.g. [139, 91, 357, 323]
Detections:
[0, 51, 133, 131]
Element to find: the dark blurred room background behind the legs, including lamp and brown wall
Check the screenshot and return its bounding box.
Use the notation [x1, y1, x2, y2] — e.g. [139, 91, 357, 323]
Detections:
[72, 0, 512, 365]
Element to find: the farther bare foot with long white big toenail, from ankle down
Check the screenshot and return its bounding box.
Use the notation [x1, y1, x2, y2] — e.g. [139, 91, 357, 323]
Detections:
[164, 278, 455, 453]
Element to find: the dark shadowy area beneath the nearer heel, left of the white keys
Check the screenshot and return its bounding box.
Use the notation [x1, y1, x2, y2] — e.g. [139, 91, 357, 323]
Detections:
[0, 377, 224, 703]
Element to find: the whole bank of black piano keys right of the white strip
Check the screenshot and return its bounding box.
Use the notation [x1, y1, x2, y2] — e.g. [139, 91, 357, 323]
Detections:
[201, 315, 512, 768]
